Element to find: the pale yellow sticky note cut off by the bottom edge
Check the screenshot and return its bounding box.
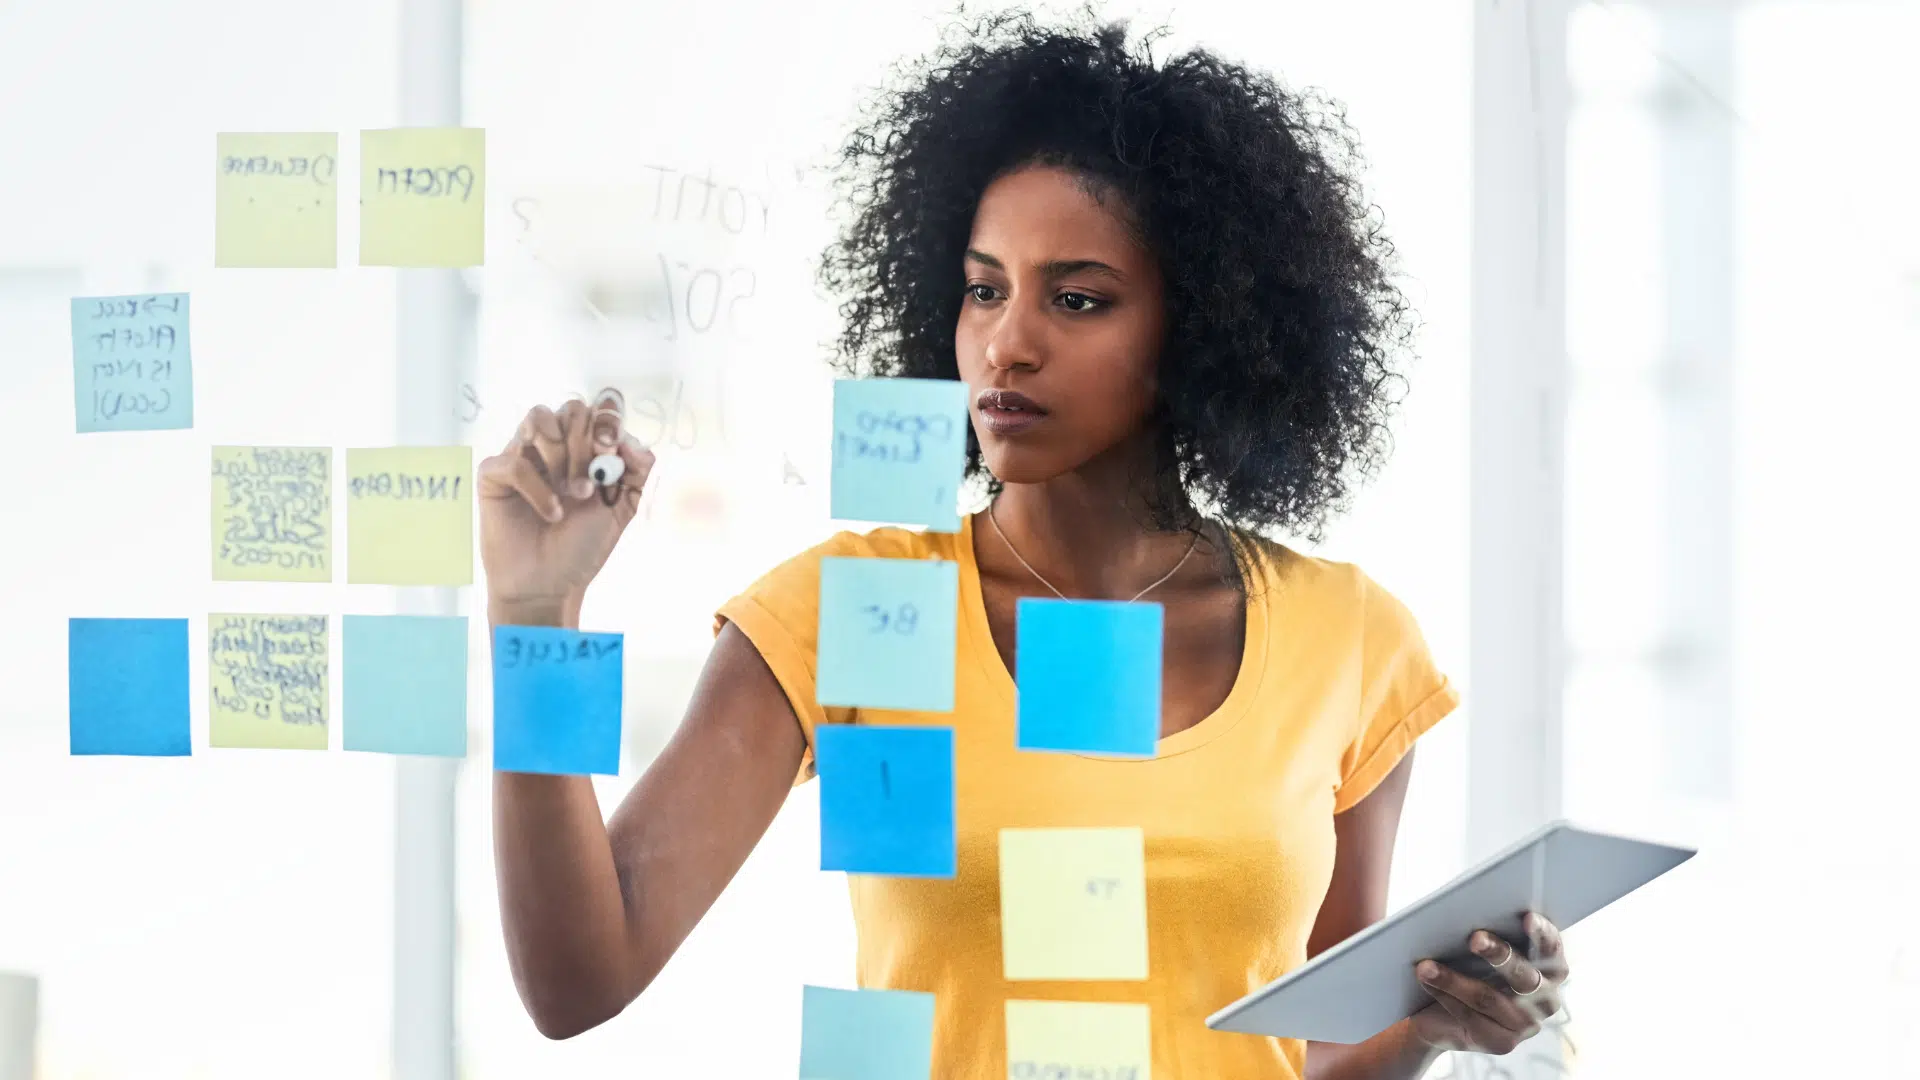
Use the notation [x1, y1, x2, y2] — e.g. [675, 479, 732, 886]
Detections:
[1006, 1001, 1154, 1080]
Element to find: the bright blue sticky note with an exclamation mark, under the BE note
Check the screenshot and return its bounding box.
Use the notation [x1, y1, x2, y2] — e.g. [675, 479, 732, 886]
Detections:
[814, 724, 954, 878]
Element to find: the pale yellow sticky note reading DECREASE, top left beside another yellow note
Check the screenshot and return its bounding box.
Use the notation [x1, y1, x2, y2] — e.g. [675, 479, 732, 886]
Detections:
[213, 131, 340, 267]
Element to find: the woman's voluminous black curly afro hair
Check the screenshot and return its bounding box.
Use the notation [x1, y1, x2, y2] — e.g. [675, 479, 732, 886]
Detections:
[820, 12, 1413, 540]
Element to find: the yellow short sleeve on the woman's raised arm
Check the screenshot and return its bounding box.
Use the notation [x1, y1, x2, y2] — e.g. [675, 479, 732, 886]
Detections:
[714, 532, 866, 786]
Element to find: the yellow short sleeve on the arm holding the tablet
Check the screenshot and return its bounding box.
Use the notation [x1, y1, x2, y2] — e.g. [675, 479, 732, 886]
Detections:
[1332, 575, 1459, 813]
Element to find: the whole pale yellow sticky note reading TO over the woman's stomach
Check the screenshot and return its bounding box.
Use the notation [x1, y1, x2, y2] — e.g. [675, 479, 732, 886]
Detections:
[998, 822, 1146, 980]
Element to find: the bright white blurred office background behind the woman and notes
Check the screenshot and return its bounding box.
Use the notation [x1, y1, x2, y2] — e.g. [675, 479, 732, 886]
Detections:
[0, 0, 1920, 1080]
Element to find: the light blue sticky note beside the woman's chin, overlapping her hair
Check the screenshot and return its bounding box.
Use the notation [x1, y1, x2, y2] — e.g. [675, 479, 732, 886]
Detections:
[831, 379, 968, 532]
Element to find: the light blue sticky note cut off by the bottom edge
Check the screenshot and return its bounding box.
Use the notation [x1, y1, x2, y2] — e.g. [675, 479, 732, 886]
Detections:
[801, 986, 933, 1080]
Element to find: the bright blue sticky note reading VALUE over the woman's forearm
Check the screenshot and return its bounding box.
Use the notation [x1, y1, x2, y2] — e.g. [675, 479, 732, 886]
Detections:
[493, 626, 622, 776]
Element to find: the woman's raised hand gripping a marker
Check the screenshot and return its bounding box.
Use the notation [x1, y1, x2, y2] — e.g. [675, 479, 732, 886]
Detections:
[476, 392, 653, 623]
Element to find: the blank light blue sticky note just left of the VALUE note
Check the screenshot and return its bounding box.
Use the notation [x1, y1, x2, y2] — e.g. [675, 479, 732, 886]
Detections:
[340, 615, 467, 757]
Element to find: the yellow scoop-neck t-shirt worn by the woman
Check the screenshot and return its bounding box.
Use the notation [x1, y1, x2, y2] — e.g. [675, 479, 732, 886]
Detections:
[714, 519, 1459, 1080]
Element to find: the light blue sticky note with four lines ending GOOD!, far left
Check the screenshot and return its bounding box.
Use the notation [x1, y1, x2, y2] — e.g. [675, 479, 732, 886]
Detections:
[73, 292, 194, 432]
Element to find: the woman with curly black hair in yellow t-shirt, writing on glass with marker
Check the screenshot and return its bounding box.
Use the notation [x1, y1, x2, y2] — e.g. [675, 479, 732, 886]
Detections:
[480, 15, 1565, 1080]
